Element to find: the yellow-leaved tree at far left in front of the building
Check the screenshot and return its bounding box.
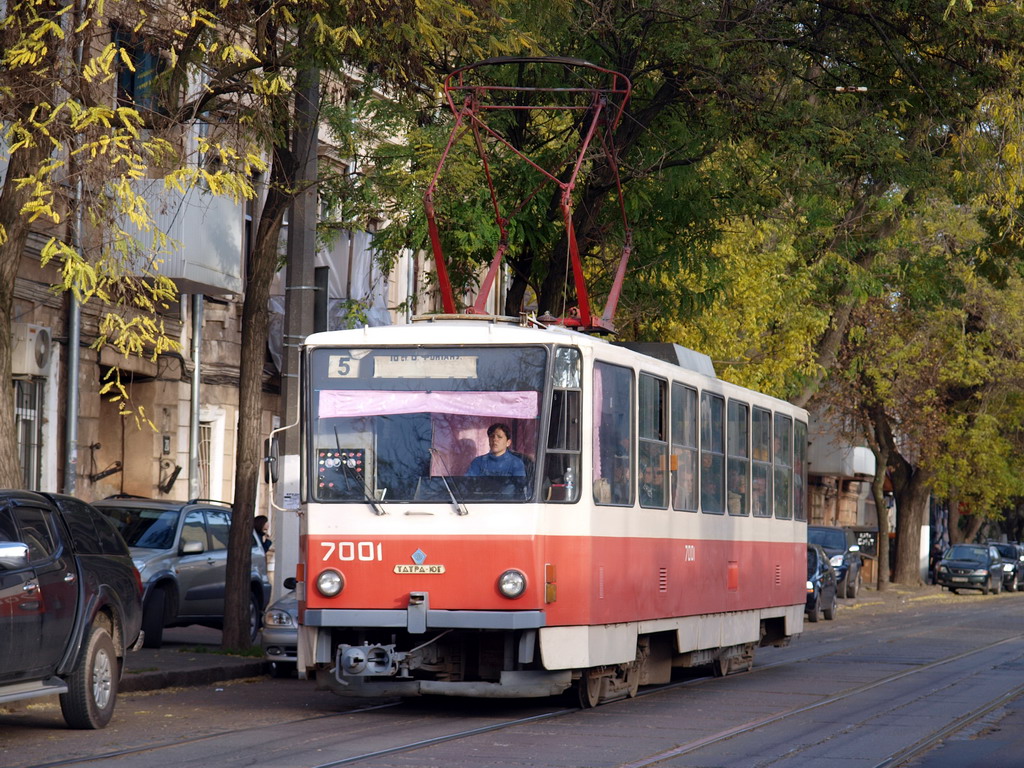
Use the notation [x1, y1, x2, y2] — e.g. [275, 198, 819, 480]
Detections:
[0, 0, 259, 495]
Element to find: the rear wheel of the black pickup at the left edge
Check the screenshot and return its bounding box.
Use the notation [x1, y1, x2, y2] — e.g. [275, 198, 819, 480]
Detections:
[60, 625, 121, 729]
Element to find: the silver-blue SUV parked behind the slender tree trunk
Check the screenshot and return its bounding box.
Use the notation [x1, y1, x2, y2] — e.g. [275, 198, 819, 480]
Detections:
[95, 498, 270, 648]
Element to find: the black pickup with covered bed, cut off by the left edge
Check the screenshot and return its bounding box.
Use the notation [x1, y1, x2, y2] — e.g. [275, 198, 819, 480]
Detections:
[0, 490, 142, 728]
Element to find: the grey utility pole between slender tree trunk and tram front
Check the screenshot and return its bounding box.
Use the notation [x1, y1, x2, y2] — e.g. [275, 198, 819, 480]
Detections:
[271, 68, 319, 594]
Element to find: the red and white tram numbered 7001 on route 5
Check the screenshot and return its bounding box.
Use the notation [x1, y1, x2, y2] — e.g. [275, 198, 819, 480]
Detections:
[288, 315, 807, 706]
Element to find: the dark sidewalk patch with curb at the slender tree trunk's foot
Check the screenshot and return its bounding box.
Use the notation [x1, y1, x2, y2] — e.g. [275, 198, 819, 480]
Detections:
[118, 627, 266, 693]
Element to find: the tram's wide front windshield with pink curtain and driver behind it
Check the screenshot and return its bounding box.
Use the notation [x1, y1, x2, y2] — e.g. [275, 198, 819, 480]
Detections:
[309, 347, 548, 504]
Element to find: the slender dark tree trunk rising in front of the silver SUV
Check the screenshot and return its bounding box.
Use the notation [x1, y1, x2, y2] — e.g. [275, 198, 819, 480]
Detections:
[221, 159, 294, 648]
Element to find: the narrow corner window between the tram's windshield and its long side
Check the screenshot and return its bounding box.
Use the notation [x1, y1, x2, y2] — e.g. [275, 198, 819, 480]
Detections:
[544, 347, 581, 502]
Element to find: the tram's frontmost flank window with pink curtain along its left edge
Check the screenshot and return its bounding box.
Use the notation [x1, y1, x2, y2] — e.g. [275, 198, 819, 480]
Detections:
[593, 362, 633, 505]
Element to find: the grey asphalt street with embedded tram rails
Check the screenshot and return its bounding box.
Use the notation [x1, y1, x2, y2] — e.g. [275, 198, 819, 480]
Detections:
[6, 588, 1024, 768]
